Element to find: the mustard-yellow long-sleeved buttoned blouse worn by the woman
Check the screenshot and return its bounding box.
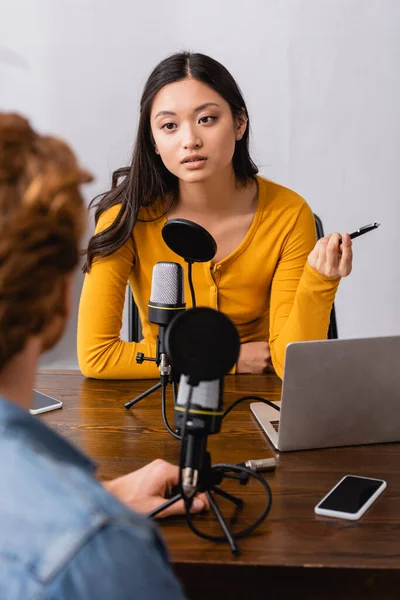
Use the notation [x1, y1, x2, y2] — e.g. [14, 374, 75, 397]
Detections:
[78, 177, 340, 379]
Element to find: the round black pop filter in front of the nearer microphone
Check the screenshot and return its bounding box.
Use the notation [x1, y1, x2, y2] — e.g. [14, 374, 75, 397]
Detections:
[165, 307, 240, 385]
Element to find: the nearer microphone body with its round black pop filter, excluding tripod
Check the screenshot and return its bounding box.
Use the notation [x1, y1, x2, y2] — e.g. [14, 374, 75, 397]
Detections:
[165, 307, 240, 498]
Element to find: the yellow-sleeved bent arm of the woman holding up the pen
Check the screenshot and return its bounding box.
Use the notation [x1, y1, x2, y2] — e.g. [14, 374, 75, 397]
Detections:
[269, 203, 340, 378]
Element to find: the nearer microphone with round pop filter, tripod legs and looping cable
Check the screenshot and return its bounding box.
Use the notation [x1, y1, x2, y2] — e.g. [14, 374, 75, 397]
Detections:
[148, 307, 271, 554]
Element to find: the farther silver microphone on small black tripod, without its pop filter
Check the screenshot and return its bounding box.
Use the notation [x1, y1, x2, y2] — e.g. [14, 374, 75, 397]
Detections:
[124, 261, 186, 422]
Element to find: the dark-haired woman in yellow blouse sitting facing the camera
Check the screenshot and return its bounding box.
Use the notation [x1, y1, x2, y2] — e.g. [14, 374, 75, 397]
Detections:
[78, 53, 352, 379]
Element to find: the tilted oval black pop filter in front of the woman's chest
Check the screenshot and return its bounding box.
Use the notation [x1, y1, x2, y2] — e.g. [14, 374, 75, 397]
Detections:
[161, 219, 217, 262]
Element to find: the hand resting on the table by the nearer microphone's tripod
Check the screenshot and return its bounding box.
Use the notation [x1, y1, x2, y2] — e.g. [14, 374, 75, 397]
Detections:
[104, 458, 209, 518]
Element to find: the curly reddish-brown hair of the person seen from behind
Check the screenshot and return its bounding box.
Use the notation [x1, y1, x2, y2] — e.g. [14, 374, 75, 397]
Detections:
[0, 113, 92, 371]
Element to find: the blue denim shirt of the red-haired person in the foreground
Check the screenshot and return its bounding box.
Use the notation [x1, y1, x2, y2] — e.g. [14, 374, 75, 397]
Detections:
[0, 397, 183, 600]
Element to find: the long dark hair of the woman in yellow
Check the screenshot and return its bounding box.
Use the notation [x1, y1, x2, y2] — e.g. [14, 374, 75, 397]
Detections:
[83, 52, 258, 273]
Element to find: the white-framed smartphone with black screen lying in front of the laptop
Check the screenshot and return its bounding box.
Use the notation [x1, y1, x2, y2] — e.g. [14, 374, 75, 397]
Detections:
[319, 475, 382, 514]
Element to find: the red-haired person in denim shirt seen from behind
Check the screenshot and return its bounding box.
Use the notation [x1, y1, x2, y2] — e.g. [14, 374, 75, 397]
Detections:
[0, 113, 206, 600]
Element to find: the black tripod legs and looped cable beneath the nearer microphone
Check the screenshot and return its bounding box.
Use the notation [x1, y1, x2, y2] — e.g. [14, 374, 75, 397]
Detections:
[147, 442, 272, 555]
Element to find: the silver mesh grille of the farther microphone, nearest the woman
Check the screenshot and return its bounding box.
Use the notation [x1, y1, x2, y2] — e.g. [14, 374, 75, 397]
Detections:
[150, 262, 184, 304]
